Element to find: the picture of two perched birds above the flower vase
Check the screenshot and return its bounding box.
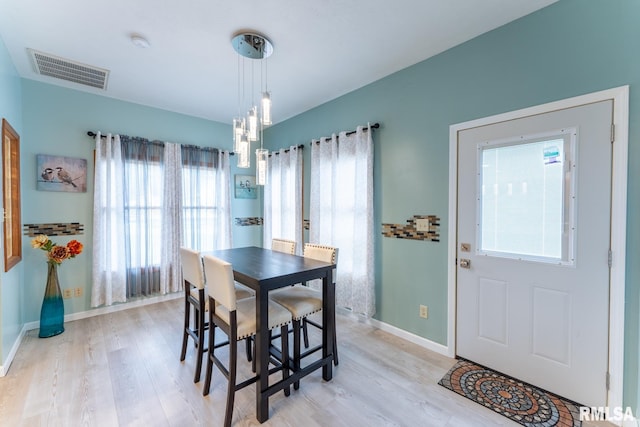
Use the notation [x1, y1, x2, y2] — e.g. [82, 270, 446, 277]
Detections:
[36, 154, 87, 193]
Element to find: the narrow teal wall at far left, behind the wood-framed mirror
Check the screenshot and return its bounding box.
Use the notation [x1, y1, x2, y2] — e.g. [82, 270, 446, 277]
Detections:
[0, 34, 24, 366]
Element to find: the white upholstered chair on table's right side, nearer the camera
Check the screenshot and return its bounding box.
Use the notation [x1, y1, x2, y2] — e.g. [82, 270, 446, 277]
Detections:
[270, 243, 338, 388]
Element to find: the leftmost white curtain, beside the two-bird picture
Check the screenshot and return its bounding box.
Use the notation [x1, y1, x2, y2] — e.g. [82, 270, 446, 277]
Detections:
[91, 132, 126, 307]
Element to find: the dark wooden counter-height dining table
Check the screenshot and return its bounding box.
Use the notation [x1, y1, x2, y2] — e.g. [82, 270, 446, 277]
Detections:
[206, 246, 336, 423]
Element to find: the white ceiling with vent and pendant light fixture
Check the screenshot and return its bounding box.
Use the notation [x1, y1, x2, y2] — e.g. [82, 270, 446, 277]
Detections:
[0, 0, 556, 123]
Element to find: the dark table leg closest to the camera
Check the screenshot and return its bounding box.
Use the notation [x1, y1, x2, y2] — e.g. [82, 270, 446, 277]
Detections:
[255, 290, 269, 423]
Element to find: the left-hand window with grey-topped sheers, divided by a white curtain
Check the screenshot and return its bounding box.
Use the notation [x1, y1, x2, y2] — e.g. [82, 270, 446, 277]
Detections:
[123, 140, 230, 296]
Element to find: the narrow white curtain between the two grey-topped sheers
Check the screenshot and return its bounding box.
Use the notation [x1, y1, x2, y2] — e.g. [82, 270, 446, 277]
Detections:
[160, 142, 184, 294]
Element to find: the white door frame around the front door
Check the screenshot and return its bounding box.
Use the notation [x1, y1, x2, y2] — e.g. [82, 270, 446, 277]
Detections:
[447, 86, 629, 414]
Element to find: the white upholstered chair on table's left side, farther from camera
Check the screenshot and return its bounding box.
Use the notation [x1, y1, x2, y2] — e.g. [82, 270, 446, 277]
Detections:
[180, 248, 252, 383]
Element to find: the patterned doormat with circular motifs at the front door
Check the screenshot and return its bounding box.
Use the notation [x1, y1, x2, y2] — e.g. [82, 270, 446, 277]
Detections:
[438, 359, 582, 427]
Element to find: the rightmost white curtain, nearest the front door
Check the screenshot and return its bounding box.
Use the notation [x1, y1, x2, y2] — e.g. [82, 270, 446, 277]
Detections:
[309, 127, 375, 317]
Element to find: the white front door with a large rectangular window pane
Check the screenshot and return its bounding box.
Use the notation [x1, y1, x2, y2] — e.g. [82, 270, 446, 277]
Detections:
[456, 100, 613, 406]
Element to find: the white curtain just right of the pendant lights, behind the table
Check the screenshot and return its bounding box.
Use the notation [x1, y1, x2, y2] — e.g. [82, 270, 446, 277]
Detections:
[263, 146, 302, 254]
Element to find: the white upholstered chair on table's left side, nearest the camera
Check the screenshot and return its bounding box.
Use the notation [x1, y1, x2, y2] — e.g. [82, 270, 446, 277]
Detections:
[202, 255, 291, 426]
